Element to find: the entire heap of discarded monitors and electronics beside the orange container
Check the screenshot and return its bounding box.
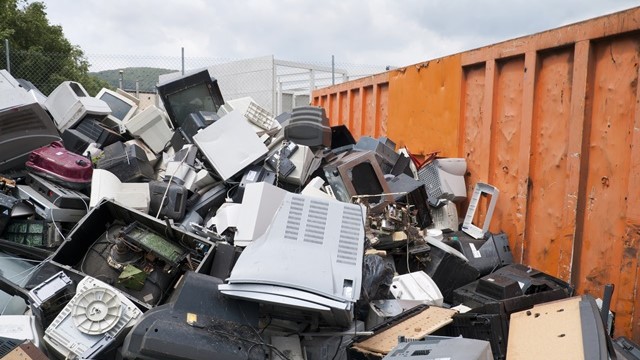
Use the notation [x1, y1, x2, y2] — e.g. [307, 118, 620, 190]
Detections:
[0, 70, 637, 360]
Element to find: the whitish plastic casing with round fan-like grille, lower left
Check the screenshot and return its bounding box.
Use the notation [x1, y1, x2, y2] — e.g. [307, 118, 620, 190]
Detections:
[44, 276, 142, 359]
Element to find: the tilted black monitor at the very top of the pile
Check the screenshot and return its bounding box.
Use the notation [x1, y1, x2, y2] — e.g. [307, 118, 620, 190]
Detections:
[158, 69, 224, 128]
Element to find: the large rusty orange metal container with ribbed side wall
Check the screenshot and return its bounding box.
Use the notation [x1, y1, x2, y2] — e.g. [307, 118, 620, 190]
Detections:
[313, 8, 640, 341]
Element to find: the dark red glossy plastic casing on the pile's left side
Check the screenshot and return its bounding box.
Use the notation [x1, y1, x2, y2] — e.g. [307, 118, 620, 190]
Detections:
[25, 141, 93, 189]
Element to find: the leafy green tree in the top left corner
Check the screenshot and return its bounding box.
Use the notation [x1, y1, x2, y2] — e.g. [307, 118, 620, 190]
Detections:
[0, 0, 110, 95]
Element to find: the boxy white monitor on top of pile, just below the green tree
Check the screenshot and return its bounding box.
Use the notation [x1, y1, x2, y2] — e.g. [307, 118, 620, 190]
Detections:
[44, 81, 111, 132]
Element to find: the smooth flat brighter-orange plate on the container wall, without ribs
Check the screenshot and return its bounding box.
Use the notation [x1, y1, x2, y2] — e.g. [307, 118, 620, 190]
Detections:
[387, 55, 462, 157]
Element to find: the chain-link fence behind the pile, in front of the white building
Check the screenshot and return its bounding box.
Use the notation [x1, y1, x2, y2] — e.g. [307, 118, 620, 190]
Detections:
[0, 42, 387, 113]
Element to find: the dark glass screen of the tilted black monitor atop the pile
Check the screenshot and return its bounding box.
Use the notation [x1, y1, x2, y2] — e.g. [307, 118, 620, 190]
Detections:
[167, 83, 218, 124]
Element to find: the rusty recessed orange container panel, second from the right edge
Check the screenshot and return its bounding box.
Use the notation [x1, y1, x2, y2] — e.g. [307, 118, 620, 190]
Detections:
[524, 48, 573, 276]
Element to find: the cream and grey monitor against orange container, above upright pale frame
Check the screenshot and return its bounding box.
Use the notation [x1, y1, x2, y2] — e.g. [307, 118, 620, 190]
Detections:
[418, 158, 467, 207]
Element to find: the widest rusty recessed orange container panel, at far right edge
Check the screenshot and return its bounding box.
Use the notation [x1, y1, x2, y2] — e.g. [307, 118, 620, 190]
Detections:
[574, 36, 640, 334]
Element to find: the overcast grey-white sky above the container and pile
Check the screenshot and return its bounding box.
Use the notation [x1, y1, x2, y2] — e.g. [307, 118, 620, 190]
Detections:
[44, 0, 640, 66]
